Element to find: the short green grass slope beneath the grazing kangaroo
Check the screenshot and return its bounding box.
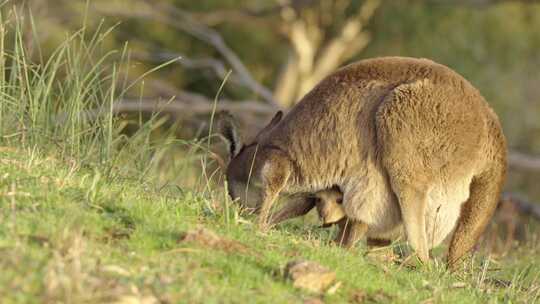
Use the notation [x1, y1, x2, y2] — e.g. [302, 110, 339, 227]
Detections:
[0, 147, 540, 303]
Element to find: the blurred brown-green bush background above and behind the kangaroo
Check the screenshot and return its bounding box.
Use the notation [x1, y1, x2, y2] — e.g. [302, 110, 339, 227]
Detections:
[4, 0, 540, 200]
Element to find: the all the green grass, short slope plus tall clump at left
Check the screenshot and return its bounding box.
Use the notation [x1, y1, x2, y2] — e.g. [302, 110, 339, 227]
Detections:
[0, 7, 540, 303]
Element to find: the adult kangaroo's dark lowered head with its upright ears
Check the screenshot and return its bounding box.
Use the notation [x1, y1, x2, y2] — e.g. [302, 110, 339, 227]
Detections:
[217, 111, 283, 211]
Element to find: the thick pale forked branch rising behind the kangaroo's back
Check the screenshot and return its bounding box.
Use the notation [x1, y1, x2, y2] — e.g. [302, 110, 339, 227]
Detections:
[275, 0, 381, 106]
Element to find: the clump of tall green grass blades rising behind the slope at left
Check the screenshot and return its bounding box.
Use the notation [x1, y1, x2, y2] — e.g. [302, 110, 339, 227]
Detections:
[0, 7, 186, 178]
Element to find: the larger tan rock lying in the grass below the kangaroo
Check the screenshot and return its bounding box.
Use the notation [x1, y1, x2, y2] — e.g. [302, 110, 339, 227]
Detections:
[285, 260, 336, 293]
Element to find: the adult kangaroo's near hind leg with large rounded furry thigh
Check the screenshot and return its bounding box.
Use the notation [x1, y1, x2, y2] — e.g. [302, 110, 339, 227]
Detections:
[375, 80, 464, 262]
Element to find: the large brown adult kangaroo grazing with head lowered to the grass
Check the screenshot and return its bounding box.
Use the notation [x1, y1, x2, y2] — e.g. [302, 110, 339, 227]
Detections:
[220, 57, 507, 269]
